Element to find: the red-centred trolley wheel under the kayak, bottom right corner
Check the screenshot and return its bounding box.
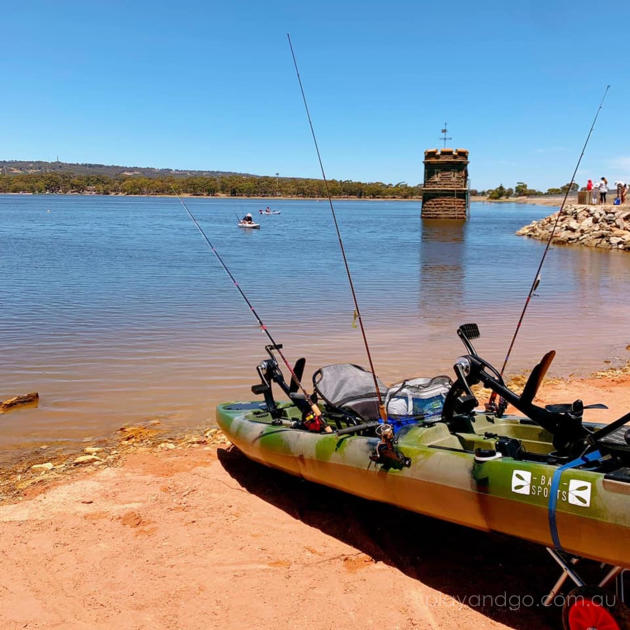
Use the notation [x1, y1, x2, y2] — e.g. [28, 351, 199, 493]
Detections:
[562, 586, 625, 630]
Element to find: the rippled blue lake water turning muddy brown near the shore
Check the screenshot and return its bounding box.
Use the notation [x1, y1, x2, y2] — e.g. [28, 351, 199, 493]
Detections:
[0, 196, 630, 458]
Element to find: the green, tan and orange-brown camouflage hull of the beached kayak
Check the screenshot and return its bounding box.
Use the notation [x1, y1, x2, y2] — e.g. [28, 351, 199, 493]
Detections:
[217, 402, 630, 568]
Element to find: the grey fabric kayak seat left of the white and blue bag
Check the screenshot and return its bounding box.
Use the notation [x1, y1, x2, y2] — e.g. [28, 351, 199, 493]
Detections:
[313, 363, 387, 422]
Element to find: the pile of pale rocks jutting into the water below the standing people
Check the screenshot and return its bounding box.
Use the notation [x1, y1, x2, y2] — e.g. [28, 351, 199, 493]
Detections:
[516, 204, 630, 251]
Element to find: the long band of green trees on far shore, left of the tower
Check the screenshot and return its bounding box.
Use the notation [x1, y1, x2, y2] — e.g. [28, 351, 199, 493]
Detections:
[0, 173, 422, 199]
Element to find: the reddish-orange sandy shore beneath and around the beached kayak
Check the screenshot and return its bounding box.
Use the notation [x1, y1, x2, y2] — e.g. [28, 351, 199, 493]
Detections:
[0, 371, 630, 630]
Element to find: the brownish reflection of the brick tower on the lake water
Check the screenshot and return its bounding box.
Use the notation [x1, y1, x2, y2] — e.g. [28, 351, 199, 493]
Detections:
[419, 219, 466, 321]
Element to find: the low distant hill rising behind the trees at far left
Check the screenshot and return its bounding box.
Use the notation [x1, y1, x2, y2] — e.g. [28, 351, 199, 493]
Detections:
[0, 160, 258, 178]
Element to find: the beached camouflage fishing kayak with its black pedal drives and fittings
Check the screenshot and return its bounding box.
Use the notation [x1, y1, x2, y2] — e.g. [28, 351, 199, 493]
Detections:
[217, 325, 630, 569]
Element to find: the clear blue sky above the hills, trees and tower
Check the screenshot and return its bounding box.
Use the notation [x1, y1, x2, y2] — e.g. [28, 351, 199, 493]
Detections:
[0, 0, 630, 189]
